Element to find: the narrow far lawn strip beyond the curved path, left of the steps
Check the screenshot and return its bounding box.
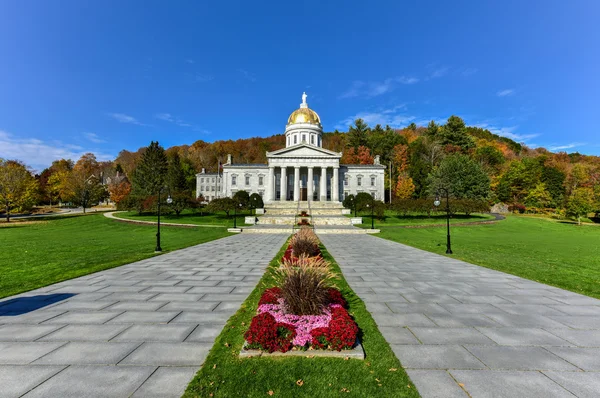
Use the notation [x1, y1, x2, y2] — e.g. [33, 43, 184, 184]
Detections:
[115, 210, 250, 227]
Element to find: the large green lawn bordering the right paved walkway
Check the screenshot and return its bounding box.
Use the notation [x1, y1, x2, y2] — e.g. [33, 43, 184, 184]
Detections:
[377, 215, 600, 298]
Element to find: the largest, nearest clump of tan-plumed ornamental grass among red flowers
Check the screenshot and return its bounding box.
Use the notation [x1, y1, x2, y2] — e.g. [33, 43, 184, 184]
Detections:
[275, 257, 335, 315]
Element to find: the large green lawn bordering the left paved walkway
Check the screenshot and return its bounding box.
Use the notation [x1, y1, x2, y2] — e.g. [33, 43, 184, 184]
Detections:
[0, 214, 230, 298]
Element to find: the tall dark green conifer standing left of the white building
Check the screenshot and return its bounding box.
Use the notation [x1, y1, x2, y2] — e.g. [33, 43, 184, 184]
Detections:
[133, 141, 168, 196]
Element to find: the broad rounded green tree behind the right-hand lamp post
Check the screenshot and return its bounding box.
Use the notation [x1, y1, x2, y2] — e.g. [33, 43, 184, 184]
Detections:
[429, 154, 490, 199]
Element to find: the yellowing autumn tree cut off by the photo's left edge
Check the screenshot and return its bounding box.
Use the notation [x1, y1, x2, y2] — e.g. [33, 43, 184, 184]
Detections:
[0, 159, 38, 222]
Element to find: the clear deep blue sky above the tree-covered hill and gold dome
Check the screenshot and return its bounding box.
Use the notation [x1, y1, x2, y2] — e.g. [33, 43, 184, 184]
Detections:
[0, 0, 600, 170]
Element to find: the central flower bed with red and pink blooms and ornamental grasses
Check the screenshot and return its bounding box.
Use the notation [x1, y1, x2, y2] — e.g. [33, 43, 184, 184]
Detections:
[244, 231, 364, 358]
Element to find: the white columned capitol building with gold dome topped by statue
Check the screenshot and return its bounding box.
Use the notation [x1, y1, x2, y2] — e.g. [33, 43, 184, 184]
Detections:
[196, 94, 385, 205]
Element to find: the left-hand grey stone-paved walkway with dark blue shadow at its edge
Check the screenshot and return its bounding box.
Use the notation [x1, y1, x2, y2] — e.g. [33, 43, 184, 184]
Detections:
[0, 234, 288, 398]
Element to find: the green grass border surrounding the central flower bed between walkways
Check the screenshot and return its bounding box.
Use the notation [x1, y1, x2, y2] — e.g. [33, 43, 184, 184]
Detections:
[184, 238, 419, 398]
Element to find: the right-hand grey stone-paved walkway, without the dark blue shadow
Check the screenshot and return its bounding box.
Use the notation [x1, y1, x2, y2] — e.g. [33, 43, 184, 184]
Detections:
[320, 235, 600, 398]
